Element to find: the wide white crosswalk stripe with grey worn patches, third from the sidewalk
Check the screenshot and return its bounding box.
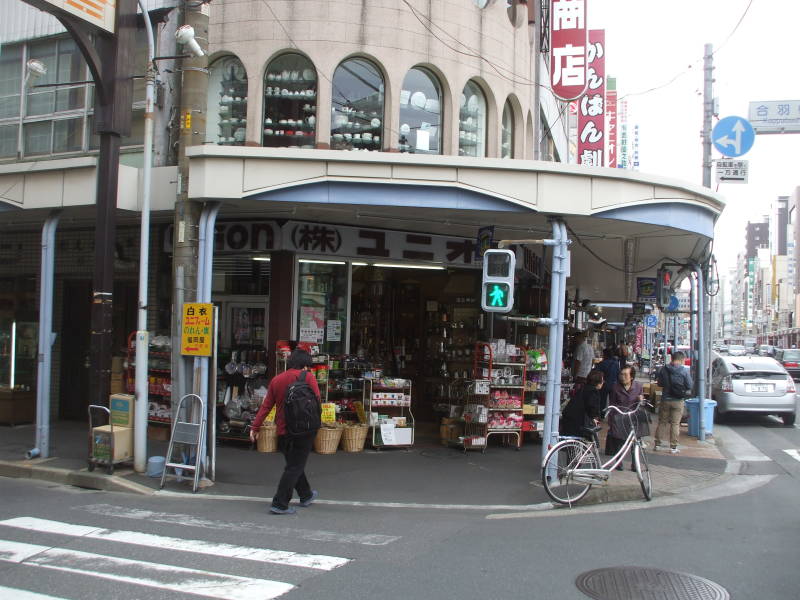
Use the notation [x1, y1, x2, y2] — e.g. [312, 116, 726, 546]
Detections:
[0, 540, 294, 600]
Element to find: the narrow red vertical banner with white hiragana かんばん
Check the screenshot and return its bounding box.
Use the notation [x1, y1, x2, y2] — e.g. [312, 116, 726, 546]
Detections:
[578, 29, 606, 167]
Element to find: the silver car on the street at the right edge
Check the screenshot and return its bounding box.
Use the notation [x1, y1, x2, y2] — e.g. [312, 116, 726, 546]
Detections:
[711, 356, 797, 425]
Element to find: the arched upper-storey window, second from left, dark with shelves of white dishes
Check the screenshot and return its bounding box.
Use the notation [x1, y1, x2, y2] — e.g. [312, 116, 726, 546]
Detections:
[264, 52, 317, 148]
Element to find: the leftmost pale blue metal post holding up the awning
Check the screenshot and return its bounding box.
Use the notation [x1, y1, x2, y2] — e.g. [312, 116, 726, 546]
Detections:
[27, 210, 61, 458]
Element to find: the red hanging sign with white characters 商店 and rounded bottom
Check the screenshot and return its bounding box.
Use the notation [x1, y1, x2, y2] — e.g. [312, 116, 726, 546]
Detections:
[550, 0, 588, 100]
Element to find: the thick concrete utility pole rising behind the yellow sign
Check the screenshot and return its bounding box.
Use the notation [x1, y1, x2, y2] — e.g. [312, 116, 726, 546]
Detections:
[172, 3, 210, 407]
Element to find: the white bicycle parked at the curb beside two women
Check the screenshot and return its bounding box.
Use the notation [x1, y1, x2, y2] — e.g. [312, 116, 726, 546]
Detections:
[542, 402, 653, 506]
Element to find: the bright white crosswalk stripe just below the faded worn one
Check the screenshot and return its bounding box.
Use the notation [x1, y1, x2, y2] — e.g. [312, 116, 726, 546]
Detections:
[0, 517, 350, 571]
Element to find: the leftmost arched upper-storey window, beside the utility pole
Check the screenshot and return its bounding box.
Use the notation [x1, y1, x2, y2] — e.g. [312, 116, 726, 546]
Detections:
[206, 56, 247, 146]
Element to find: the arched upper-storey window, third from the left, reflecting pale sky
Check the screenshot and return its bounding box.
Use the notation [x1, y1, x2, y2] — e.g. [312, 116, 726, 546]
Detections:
[331, 58, 384, 150]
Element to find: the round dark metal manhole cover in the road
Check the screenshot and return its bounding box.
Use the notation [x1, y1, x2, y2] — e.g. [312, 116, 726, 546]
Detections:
[575, 567, 730, 600]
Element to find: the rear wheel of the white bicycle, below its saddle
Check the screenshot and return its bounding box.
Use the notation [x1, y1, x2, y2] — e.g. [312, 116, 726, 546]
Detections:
[542, 440, 599, 505]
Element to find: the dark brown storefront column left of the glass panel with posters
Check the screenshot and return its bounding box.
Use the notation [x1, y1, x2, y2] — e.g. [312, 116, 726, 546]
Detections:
[267, 251, 297, 375]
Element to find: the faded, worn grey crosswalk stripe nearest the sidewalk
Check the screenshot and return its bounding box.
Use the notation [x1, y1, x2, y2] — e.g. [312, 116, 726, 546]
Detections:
[81, 504, 400, 546]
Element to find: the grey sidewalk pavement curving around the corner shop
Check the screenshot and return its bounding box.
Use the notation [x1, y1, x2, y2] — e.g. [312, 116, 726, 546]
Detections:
[0, 421, 731, 510]
